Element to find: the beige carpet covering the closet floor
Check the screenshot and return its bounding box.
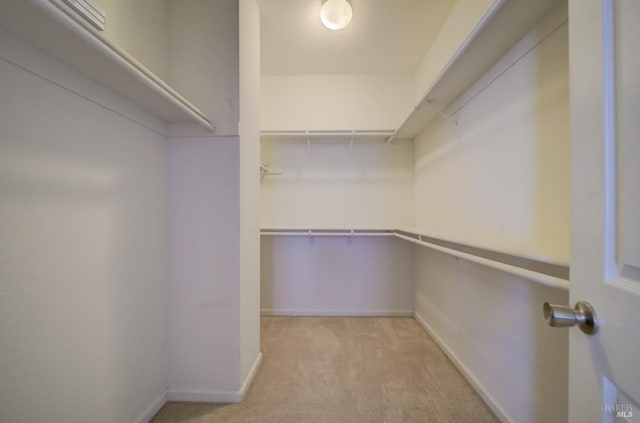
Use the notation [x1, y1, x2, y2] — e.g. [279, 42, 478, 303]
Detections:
[152, 317, 497, 423]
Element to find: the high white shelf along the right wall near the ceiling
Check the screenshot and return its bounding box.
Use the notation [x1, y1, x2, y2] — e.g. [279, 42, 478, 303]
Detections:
[387, 0, 566, 142]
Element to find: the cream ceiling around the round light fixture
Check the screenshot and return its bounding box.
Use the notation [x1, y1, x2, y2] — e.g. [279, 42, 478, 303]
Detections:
[258, 0, 455, 75]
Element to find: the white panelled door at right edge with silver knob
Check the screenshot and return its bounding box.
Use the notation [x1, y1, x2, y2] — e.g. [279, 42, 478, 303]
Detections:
[569, 0, 640, 423]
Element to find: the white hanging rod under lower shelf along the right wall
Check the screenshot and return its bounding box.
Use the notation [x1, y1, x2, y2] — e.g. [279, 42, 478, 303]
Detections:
[395, 232, 569, 291]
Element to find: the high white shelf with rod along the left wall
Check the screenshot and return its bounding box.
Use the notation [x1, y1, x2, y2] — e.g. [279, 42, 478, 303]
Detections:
[0, 0, 215, 131]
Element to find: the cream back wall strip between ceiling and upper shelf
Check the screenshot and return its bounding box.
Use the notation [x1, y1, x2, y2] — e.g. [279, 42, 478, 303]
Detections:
[260, 75, 413, 131]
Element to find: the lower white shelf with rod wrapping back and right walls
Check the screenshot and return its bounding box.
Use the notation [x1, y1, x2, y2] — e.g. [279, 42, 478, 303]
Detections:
[260, 227, 569, 291]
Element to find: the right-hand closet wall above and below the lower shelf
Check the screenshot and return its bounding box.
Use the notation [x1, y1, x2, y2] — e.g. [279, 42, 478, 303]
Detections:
[415, 14, 569, 422]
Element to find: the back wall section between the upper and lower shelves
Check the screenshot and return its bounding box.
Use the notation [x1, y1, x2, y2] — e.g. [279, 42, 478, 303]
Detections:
[260, 139, 413, 228]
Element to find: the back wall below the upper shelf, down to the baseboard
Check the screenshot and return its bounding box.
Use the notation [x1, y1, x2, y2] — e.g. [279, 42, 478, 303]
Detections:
[260, 140, 413, 315]
